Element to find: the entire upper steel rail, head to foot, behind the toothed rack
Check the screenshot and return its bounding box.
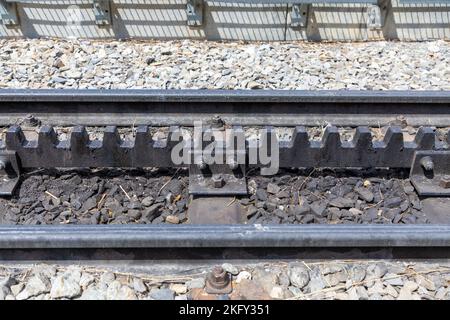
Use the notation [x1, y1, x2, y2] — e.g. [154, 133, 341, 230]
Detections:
[0, 89, 450, 126]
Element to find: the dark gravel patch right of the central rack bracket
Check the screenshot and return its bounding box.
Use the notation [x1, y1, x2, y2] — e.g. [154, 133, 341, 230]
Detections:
[241, 170, 428, 224]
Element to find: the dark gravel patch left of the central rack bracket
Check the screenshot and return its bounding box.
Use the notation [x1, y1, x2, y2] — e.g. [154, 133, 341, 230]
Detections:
[0, 169, 188, 224]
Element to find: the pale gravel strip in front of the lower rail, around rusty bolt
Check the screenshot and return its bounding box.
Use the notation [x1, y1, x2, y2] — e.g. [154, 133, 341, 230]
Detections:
[0, 260, 450, 300]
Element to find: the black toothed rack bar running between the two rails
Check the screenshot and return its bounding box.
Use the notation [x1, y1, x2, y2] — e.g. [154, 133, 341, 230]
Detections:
[0, 125, 450, 168]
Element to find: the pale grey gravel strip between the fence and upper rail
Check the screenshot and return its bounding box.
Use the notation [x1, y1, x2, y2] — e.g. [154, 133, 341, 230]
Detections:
[0, 39, 450, 90]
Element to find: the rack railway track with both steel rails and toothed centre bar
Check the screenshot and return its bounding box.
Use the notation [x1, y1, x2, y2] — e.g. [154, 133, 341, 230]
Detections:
[0, 90, 450, 260]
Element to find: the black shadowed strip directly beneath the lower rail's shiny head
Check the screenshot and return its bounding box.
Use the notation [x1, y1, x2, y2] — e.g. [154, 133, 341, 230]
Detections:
[0, 247, 450, 266]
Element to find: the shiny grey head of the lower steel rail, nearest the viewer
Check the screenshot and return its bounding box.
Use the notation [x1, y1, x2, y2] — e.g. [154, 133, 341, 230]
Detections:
[0, 224, 450, 250]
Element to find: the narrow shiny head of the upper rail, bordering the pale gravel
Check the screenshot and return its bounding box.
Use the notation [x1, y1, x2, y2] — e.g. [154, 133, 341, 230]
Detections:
[0, 89, 450, 103]
